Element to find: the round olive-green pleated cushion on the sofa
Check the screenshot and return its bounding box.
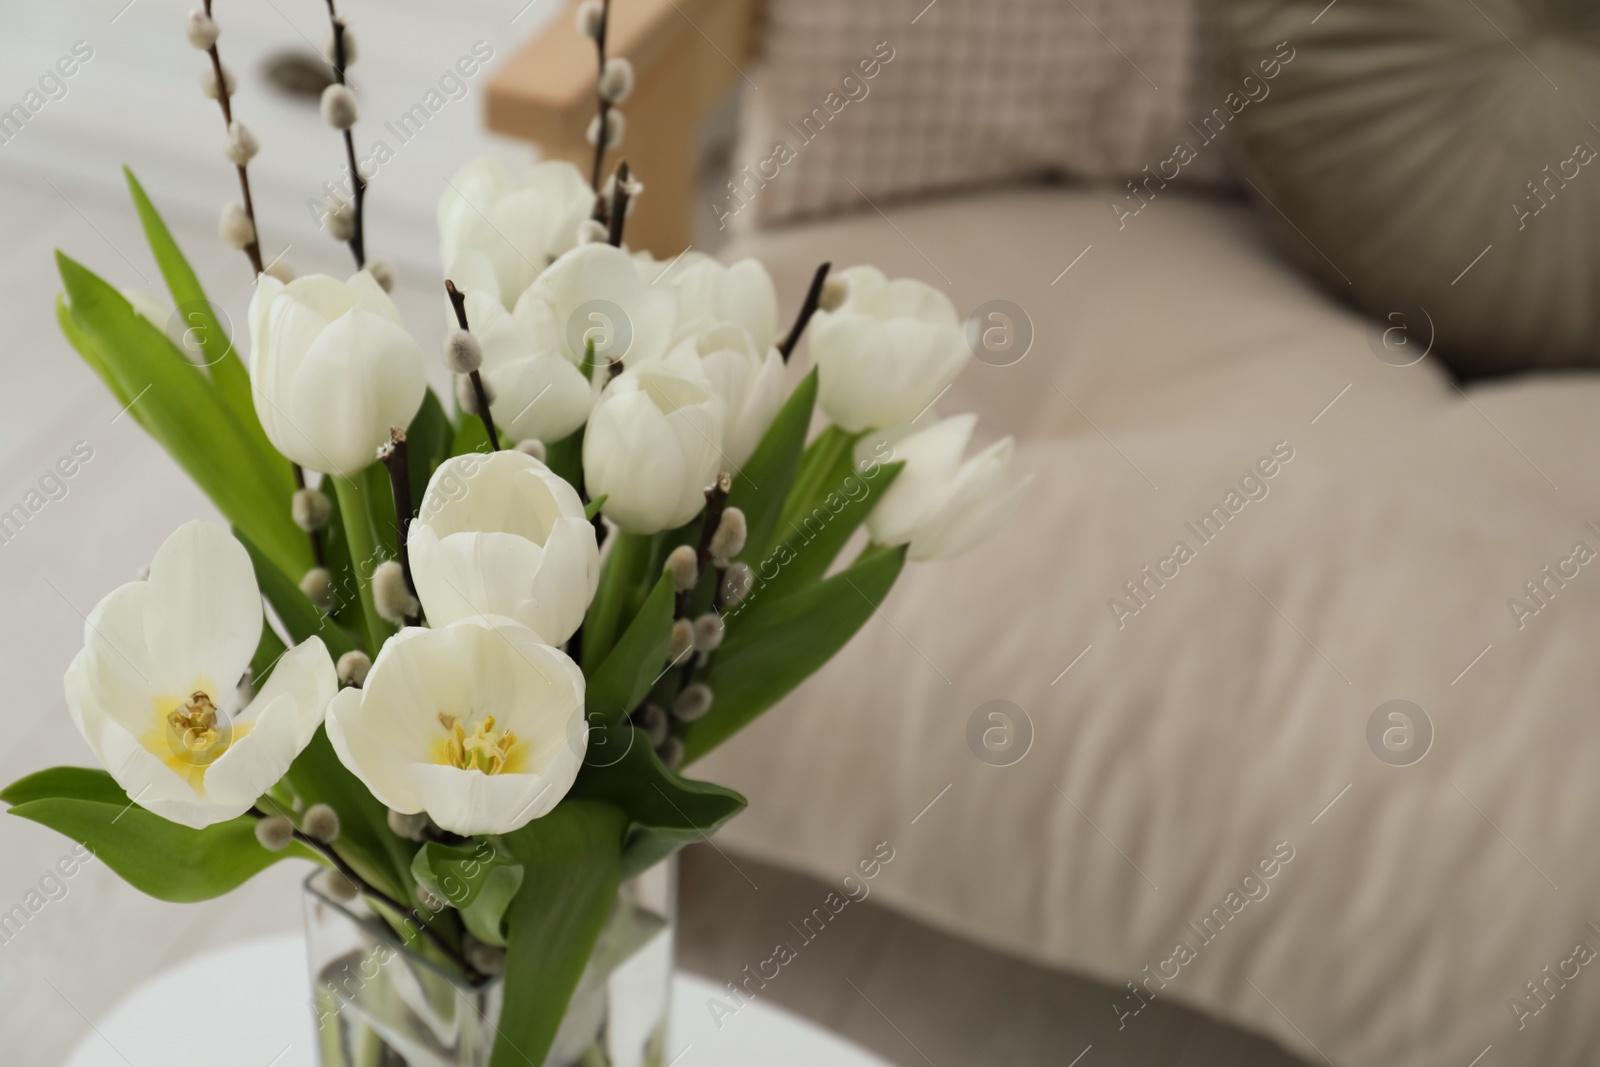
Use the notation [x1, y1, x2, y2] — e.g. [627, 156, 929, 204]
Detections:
[1222, 0, 1600, 374]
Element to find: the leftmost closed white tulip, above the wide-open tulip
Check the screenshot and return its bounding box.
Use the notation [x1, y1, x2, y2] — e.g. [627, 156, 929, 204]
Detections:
[250, 270, 427, 477]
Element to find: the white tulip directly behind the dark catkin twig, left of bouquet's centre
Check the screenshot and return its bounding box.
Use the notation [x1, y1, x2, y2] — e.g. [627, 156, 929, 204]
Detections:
[466, 281, 594, 442]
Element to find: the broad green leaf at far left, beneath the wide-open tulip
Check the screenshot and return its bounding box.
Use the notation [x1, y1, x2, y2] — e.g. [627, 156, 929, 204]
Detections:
[0, 766, 318, 904]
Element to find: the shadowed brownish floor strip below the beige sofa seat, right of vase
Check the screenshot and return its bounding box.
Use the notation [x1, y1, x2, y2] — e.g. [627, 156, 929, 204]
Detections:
[678, 845, 1304, 1067]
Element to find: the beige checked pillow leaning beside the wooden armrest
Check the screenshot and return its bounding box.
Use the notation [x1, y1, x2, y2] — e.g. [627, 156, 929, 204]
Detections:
[732, 0, 1227, 227]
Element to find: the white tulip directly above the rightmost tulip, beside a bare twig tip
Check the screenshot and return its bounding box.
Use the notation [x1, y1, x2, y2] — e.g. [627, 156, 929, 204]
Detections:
[810, 267, 971, 434]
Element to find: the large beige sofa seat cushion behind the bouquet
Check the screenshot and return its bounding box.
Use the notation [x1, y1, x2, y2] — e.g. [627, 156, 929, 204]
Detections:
[707, 190, 1600, 1067]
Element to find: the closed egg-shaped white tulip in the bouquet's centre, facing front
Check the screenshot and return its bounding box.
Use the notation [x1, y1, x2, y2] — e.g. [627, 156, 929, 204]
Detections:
[584, 352, 731, 534]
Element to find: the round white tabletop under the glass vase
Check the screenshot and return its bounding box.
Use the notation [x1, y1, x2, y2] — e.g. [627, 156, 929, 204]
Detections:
[64, 934, 886, 1067]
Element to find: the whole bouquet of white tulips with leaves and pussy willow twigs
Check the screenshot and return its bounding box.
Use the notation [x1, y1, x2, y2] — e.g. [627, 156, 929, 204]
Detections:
[0, 0, 1022, 1065]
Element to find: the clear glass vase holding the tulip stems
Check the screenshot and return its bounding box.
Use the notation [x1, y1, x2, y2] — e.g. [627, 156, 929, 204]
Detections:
[306, 857, 677, 1067]
